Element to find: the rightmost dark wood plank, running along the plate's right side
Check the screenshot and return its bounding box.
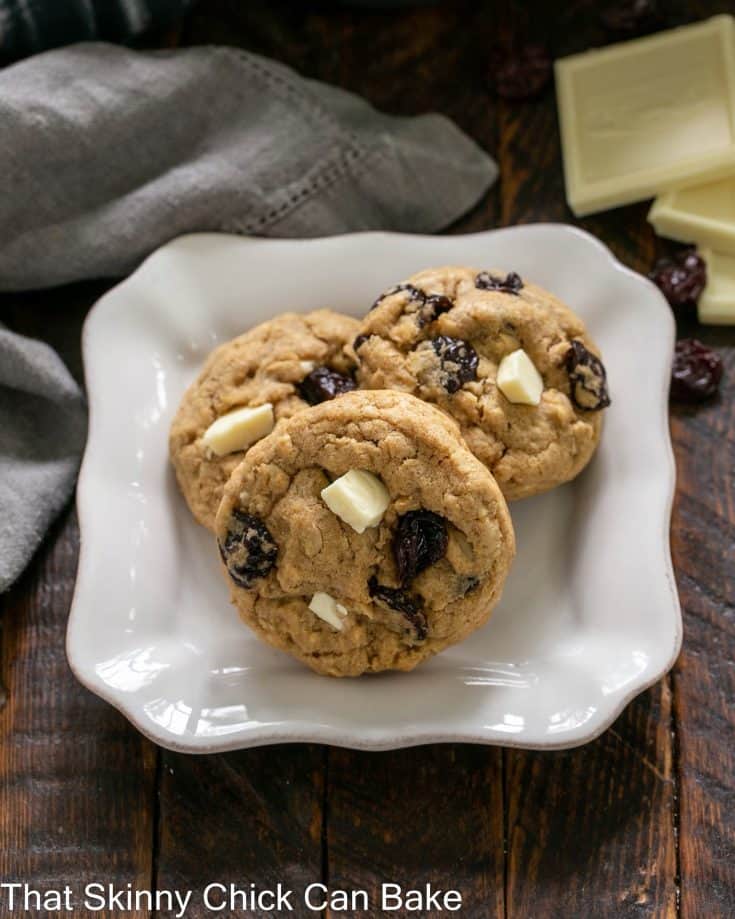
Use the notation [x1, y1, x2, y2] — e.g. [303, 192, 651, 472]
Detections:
[672, 327, 735, 919]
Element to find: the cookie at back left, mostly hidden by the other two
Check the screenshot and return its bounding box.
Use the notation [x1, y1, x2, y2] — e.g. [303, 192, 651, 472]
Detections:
[169, 310, 358, 529]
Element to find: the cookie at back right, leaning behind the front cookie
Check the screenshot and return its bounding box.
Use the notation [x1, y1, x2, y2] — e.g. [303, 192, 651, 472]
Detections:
[354, 267, 610, 499]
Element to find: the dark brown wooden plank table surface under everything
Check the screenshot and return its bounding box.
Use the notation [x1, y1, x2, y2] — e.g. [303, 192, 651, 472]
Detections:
[0, 0, 735, 919]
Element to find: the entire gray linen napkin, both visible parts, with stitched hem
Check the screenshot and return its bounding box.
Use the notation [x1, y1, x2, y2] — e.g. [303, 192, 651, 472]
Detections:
[0, 43, 497, 590]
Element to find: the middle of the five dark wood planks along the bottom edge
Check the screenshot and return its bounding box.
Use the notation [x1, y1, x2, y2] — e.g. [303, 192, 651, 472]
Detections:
[327, 744, 505, 919]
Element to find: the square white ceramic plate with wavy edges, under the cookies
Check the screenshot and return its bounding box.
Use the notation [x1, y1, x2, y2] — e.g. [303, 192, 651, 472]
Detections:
[68, 224, 681, 752]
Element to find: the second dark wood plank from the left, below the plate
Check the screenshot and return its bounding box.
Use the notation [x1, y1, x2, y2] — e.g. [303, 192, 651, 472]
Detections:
[156, 745, 326, 919]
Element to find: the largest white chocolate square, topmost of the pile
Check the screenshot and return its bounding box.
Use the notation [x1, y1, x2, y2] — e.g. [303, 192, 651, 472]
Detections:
[555, 15, 735, 216]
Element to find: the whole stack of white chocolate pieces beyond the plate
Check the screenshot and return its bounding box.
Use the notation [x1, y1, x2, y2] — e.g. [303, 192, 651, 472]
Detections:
[556, 16, 735, 324]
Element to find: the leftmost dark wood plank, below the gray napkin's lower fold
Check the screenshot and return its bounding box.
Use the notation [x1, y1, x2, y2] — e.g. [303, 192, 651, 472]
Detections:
[0, 508, 156, 919]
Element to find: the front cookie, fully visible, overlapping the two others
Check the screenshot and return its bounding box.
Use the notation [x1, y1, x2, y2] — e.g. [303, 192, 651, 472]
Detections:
[216, 391, 515, 676]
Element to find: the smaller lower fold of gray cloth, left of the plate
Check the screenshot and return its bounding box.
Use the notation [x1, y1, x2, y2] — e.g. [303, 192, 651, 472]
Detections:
[0, 326, 87, 591]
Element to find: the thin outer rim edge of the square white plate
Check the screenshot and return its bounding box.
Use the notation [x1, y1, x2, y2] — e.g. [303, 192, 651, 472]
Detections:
[65, 221, 683, 755]
